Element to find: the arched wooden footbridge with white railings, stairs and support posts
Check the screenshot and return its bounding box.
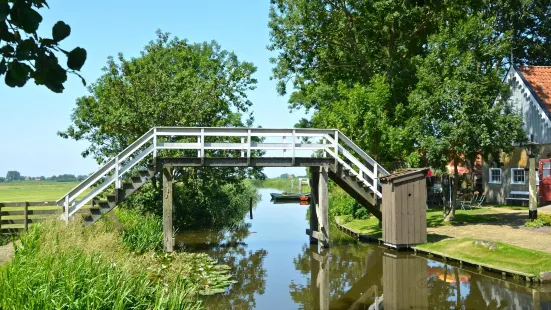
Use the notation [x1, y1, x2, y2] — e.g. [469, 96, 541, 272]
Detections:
[57, 127, 388, 251]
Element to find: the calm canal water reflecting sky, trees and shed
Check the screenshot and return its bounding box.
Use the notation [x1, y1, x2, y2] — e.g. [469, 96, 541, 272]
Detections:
[177, 189, 551, 310]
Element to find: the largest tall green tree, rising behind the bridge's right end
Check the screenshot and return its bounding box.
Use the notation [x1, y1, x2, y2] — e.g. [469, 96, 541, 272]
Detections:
[269, 0, 551, 170]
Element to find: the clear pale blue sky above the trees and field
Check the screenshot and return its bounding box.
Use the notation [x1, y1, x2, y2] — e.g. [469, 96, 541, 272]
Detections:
[0, 0, 310, 176]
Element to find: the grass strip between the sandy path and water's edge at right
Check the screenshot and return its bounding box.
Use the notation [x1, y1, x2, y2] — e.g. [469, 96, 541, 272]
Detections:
[417, 238, 551, 276]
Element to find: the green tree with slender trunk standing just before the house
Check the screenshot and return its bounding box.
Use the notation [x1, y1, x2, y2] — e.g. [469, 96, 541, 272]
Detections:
[408, 7, 526, 220]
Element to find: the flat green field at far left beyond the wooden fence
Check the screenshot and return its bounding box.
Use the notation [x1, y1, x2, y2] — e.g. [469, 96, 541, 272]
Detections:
[0, 181, 78, 202]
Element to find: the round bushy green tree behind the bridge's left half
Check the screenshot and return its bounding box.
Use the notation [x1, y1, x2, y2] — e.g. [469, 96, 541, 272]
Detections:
[59, 31, 262, 226]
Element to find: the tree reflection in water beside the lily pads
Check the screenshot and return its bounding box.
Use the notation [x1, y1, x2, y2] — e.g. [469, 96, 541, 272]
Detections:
[177, 223, 268, 309]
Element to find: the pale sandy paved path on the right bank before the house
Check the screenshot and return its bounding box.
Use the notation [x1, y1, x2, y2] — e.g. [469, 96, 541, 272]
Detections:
[428, 206, 551, 253]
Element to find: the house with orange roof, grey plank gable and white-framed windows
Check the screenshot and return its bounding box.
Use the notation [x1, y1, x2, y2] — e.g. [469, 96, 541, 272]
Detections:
[483, 66, 551, 204]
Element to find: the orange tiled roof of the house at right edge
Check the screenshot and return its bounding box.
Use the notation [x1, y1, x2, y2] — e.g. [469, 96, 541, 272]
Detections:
[515, 66, 551, 116]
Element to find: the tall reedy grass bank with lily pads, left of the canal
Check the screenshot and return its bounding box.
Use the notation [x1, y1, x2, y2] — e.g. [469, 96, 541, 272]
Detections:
[0, 210, 232, 309]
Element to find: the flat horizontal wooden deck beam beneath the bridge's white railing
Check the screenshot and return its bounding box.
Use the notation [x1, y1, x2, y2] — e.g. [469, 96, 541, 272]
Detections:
[156, 157, 335, 169]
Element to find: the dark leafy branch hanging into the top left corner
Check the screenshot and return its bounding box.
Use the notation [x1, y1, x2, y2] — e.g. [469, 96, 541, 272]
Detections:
[0, 0, 86, 93]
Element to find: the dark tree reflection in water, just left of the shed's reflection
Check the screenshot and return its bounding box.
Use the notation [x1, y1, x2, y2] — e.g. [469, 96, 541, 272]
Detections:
[289, 231, 382, 309]
